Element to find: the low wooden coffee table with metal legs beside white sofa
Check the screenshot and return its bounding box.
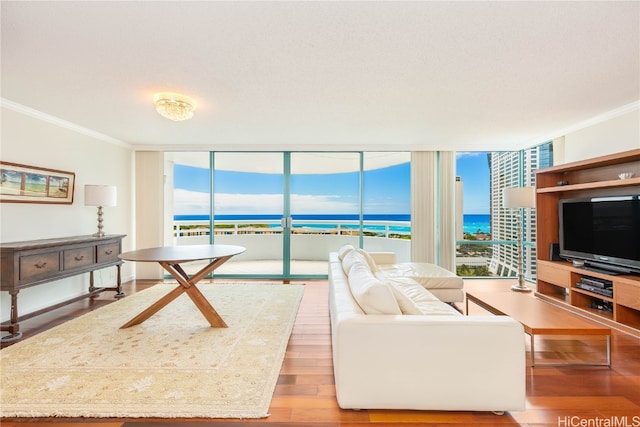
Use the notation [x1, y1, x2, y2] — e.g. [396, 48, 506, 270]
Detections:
[466, 291, 611, 367]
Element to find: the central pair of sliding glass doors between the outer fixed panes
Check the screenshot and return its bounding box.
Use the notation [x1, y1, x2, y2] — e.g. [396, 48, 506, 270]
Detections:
[212, 152, 360, 279]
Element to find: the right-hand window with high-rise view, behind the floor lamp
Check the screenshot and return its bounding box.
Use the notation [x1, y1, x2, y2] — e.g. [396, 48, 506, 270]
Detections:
[457, 142, 553, 280]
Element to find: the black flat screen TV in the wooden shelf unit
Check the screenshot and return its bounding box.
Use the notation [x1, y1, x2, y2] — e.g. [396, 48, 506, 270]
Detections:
[559, 194, 640, 274]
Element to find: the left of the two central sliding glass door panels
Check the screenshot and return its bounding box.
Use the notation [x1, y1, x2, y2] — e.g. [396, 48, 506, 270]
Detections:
[212, 152, 287, 278]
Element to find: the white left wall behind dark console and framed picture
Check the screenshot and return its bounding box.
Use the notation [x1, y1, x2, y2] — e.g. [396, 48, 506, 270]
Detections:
[0, 106, 134, 321]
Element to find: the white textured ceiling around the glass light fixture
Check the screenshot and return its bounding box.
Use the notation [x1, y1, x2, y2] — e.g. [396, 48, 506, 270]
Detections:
[1, 1, 640, 150]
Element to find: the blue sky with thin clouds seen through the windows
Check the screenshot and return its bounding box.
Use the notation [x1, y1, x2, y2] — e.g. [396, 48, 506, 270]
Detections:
[174, 153, 489, 215]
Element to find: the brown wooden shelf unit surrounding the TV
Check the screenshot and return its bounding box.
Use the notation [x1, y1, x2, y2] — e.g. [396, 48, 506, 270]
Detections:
[536, 149, 640, 336]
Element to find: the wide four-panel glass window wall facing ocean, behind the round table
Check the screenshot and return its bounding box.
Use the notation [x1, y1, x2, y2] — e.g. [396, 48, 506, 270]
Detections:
[167, 152, 411, 279]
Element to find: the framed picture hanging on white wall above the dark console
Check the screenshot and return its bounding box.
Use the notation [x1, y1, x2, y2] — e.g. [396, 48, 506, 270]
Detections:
[0, 161, 76, 205]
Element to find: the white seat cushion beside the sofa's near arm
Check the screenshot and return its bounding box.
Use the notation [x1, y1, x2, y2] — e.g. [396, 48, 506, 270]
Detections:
[386, 277, 459, 315]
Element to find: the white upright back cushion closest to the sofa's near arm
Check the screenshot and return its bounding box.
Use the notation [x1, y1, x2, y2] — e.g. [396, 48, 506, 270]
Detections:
[345, 257, 402, 314]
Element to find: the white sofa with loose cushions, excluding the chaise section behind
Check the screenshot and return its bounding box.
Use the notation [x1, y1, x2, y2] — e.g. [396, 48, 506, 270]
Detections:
[329, 248, 525, 412]
